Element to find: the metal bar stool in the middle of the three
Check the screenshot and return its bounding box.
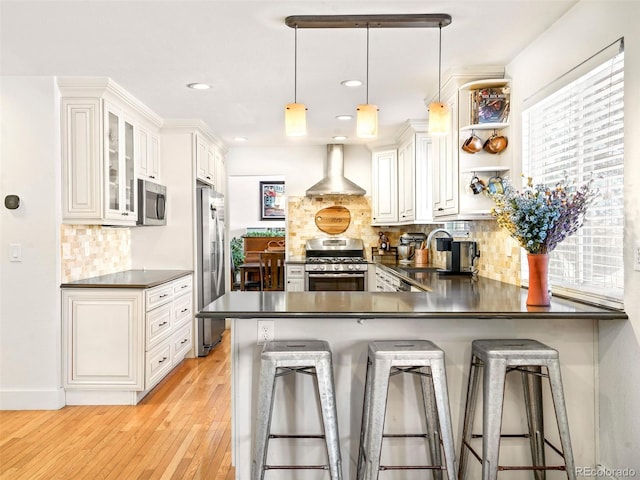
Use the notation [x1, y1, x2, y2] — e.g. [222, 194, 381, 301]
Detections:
[357, 340, 456, 480]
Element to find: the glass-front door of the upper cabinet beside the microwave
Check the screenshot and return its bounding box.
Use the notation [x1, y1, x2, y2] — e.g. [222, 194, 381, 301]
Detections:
[104, 104, 137, 224]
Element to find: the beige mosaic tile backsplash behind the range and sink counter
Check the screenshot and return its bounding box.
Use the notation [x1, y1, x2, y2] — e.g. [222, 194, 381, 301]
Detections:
[287, 195, 520, 285]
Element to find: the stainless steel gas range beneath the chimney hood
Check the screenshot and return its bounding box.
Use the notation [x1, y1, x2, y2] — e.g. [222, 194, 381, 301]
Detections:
[304, 237, 369, 292]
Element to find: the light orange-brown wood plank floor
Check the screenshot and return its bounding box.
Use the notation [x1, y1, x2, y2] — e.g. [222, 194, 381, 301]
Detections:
[0, 331, 235, 480]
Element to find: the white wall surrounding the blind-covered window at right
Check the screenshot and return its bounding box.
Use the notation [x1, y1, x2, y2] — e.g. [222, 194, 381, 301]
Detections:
[507, 0, 640, 473]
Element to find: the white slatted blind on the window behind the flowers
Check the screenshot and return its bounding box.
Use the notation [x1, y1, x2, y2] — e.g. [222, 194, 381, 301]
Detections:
[521, 45, 624, 307]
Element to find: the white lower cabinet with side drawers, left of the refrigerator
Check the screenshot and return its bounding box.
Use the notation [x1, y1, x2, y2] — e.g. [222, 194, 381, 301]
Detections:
[62, 275, 193, 405]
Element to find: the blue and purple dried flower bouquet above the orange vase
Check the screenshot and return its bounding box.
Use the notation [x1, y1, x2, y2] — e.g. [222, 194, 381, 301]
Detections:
[490, 173, 598, 254]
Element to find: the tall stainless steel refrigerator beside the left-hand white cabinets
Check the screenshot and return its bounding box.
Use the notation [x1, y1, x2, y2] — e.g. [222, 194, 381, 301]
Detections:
[197, 186, 226, 357]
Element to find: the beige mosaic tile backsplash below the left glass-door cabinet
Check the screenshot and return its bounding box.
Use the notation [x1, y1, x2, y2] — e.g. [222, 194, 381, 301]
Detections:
[60, 225, 131, 283]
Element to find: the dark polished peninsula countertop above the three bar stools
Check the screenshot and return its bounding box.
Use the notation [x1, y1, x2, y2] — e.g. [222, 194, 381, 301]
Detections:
[197, 288, 628, 320]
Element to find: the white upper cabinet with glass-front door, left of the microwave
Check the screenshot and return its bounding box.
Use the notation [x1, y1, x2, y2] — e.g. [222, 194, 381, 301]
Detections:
[58, 78, 162, 226]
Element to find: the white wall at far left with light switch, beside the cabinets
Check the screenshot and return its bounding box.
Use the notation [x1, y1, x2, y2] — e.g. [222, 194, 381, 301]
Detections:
[0, 77, 64, 409]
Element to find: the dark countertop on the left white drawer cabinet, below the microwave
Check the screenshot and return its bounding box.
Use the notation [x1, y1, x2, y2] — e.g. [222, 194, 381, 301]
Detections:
[60, 270, 193, 288]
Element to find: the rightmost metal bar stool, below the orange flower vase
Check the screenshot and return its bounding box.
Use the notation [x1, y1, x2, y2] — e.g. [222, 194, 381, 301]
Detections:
[458, 339, 576, 480]
